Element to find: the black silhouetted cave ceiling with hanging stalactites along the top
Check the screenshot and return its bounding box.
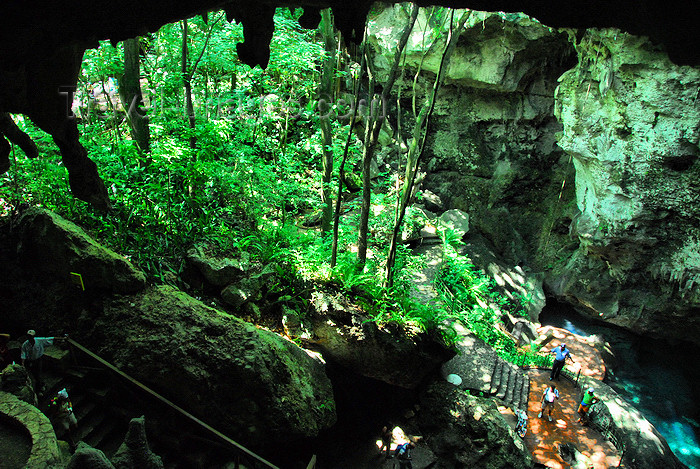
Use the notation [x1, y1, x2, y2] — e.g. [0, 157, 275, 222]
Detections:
[0, 0, 700, 208]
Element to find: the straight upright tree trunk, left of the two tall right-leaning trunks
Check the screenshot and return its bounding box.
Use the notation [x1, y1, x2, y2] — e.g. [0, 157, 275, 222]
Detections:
[318, 8, 336, 233]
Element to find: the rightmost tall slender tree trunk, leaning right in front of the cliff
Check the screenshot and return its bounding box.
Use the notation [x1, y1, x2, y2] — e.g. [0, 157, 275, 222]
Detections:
[384, 10, 471, 288]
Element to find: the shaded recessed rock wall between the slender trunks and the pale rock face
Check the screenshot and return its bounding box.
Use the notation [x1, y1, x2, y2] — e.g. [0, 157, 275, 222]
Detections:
[369, 6, 576, 308]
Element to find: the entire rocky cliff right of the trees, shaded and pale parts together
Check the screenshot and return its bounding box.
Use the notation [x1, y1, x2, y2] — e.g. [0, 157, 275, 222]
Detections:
[369, 6, 700, 342]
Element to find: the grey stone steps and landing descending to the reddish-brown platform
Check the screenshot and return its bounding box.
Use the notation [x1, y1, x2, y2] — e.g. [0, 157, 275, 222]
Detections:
[441, 324, 530, 410]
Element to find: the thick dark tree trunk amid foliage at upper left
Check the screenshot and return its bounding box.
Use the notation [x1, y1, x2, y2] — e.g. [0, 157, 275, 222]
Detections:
[119, 38, 151, 153]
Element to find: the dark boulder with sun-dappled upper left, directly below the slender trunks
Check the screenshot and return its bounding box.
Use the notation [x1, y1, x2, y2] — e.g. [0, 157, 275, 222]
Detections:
[305, 290, 454, 388]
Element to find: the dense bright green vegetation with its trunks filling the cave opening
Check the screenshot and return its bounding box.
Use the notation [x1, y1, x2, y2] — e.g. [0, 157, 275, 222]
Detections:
[0, 5, 536, 358]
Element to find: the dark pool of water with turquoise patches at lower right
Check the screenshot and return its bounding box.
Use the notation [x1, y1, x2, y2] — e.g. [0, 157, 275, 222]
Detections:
[540, 303, 700, 469]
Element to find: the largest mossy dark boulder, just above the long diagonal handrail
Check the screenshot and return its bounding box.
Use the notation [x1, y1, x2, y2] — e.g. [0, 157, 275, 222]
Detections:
[75, 286, 336, 446]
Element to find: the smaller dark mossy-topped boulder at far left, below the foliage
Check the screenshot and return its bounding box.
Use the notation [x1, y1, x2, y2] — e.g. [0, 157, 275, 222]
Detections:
[15, 207, 146, 293]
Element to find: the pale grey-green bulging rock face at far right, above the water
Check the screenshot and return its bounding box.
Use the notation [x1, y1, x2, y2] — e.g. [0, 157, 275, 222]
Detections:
[547, 30, 700, 343]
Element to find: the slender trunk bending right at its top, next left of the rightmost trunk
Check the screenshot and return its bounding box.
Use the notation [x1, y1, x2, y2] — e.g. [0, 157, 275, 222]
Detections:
[357, 4, 419, 269]
